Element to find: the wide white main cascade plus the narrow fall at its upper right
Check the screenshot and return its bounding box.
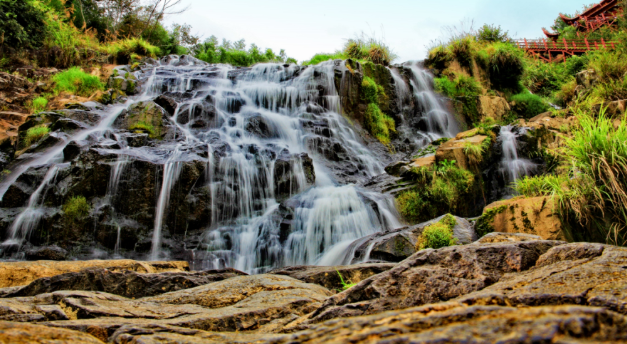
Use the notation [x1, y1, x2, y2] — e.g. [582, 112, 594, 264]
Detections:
[0, 57, 457, 273]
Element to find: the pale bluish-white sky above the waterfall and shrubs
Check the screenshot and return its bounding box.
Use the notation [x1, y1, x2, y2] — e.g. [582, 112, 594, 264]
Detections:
[167, 0, 592, 63]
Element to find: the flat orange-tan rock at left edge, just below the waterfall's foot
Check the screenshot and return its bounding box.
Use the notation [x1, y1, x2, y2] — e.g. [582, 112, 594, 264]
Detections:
[0, 260, 189, 288]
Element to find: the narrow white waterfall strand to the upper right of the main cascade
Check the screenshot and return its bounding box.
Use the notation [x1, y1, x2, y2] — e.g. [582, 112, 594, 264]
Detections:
[405, 63, 459, 140]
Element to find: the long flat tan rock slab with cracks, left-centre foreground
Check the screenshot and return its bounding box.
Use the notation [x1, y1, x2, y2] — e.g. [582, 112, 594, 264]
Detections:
[35, 275, 332, 340]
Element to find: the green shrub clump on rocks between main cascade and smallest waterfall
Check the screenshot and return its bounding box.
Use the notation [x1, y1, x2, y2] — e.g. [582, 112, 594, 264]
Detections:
[396, 161, 475, 223]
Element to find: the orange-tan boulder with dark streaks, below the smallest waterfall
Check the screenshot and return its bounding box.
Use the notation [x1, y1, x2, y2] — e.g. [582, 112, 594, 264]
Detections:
[476, 197, 572, 241]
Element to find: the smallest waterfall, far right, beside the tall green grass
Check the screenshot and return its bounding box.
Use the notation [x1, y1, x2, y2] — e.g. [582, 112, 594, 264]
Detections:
[499, 125, 536, 183]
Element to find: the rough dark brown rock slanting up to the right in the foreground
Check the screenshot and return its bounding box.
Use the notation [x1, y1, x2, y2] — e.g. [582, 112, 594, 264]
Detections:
[309, 241, 564, 322]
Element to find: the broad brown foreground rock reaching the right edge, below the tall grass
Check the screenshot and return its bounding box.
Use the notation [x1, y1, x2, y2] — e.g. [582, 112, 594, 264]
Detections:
[458, 243, 627, 314]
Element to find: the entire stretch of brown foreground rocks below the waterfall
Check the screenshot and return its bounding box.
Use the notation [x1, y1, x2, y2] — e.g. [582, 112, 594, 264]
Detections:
[0, 233, 627, 343]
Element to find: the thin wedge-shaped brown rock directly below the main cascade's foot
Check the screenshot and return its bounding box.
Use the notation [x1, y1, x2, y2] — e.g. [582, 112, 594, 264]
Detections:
[268, 263, 396, 291]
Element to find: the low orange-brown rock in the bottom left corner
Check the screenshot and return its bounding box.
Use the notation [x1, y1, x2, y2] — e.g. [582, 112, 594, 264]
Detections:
[0, 321, 102, 344]
